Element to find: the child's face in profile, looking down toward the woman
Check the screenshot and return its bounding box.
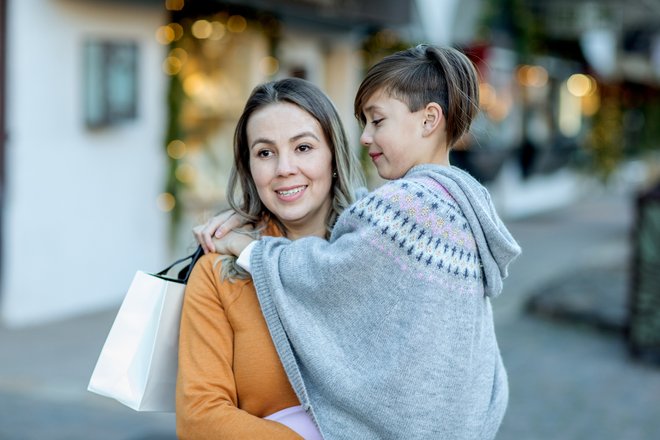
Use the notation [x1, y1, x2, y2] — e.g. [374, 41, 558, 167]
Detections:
[360, 90, 432, 180]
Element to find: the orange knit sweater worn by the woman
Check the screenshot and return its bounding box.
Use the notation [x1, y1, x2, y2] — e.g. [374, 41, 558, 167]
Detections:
[176, 224, 301, 440]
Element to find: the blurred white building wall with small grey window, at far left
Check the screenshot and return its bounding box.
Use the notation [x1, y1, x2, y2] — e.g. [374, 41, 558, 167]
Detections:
[0, 0, 167, 326]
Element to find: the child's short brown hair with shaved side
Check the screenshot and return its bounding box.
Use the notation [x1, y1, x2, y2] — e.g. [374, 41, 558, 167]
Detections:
[355, 44, 479, 148]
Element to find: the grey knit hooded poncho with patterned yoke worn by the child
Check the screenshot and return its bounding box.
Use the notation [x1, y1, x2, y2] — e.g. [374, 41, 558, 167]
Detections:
[250, 165, 520, 440]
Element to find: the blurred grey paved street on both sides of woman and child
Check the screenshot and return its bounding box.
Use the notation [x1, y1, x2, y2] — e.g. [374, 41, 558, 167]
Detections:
[0, 184, 660, 440]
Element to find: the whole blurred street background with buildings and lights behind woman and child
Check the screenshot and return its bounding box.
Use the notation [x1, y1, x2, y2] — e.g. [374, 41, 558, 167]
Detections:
[0, 0, 660, 440]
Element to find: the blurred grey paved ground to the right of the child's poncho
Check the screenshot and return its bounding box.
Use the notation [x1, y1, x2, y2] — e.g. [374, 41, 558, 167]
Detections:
[494, 187, 660, 440]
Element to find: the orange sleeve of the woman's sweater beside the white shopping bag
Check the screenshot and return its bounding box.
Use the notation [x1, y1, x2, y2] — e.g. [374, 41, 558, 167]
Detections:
[176, 255, 300, 440]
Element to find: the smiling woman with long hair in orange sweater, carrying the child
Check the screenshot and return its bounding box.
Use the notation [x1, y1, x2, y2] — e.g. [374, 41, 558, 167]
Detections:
[176, 79, 363, 440]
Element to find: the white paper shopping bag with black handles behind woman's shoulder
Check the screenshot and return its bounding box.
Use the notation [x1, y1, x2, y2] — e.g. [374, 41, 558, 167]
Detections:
[87, 248, 202, 412]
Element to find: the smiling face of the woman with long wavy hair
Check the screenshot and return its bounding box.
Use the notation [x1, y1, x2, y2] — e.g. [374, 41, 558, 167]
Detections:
[246, 103, 332, 238]
